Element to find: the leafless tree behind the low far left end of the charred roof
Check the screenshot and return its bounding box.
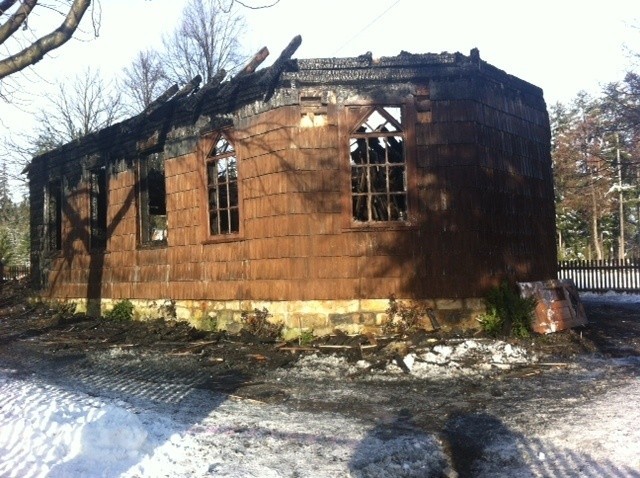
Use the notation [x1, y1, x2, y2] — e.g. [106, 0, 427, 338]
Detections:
[35, 68, 123, 152]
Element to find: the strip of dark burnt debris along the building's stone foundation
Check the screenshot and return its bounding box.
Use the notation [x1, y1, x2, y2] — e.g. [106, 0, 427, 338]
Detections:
[0, 281, 640, 376]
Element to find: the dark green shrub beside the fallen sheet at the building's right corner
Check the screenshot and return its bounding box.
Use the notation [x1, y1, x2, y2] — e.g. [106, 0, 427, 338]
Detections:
[478, 281, 537, 337]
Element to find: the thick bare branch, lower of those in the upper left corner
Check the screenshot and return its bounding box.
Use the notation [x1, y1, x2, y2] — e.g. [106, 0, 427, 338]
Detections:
[0, 0, 91, 80]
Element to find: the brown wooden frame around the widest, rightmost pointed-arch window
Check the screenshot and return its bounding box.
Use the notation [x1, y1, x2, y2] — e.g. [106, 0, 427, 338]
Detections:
[341, 101, 416, 230]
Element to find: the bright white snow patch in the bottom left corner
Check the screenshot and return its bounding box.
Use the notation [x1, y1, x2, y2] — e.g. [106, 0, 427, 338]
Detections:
[0, 377, 146, 477]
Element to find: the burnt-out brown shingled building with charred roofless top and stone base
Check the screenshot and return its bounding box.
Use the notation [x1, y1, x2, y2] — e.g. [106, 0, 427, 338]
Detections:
[28, 37, 556, 331]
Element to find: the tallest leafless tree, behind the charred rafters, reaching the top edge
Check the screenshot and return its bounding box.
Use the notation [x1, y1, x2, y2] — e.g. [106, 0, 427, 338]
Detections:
[163, 0, 246, 85]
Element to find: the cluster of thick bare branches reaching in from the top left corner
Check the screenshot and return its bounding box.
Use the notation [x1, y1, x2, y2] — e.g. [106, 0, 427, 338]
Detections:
[0, 0, 91, 80]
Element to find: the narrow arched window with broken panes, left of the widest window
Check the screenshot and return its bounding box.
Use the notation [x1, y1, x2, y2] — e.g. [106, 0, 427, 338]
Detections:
[206, 135, 240, 236]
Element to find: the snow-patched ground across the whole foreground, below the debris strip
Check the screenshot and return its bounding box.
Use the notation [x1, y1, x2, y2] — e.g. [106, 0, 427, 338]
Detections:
[0, 298, 640, 478]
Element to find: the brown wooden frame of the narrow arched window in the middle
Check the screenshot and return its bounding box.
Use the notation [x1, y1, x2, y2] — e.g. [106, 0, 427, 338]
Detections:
[200, 129, 244, 243]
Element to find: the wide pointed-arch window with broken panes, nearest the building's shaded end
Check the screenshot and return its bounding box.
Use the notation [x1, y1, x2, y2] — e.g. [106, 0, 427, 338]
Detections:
[349, 106, 407, 222]
